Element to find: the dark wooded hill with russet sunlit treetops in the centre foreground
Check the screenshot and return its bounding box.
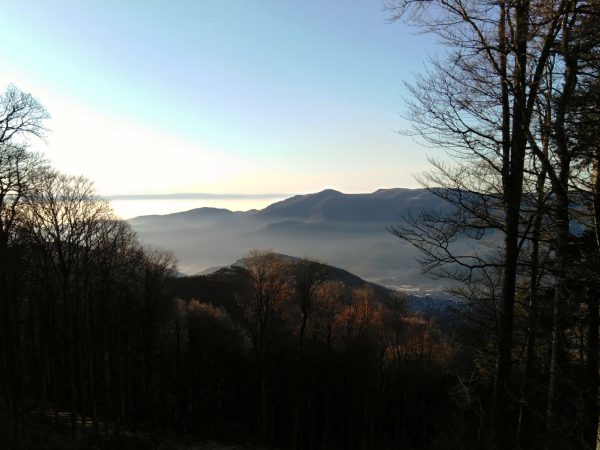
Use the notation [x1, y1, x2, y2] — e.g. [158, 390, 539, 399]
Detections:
[155, 251, 454, 448]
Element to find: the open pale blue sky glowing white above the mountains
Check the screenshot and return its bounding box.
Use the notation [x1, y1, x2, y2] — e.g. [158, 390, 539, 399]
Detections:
[0, 0, 436, 202]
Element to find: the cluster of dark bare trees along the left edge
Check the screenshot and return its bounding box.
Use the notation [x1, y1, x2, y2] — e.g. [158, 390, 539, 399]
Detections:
[0, 86, 175, 435]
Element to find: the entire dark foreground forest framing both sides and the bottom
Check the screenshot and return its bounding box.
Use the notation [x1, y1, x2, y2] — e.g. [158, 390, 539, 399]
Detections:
[0, 0, 600, 450]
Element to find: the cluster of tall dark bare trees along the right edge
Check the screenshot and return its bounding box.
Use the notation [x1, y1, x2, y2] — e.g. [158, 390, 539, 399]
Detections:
[388, 0, 600, 450]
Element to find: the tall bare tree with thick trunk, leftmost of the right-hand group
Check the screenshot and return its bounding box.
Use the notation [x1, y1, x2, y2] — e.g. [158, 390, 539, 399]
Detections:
[389, 0, 572, 449]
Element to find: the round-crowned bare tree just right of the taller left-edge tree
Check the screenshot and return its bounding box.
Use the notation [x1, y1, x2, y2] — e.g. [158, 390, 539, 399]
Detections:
[23, 170, 115, 430]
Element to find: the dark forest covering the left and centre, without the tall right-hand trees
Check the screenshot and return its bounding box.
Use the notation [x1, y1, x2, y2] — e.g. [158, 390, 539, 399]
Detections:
[0, 97, 452, 448]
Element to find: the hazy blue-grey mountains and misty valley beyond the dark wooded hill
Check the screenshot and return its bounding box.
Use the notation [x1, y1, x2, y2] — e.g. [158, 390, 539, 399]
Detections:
[129, 188, 460, 291]
